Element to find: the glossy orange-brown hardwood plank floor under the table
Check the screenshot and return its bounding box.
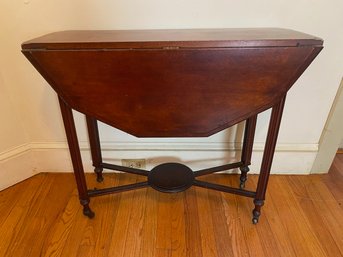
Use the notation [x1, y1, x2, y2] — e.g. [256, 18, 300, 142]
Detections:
[0, 154, 343, 257]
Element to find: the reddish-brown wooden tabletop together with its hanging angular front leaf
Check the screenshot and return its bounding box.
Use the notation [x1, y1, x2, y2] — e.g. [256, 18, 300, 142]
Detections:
[22, 29, 322, 137]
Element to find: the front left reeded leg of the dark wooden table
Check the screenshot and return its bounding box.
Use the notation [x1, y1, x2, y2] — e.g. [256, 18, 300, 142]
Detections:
[58, 97, 94, 218]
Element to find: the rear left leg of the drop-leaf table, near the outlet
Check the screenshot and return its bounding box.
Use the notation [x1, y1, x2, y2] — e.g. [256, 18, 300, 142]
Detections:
[86, 115, 104, 182]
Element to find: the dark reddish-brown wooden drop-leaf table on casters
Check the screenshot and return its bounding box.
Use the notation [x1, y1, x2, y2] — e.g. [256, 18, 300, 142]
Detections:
[22, 28, 323, 223]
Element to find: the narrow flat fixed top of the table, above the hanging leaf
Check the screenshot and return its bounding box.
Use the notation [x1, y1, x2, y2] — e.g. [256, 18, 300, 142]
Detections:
[23, 28, 322, 50]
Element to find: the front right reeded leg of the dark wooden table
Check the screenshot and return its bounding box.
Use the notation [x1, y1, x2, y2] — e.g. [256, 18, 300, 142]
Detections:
[252, 96, 286, 224]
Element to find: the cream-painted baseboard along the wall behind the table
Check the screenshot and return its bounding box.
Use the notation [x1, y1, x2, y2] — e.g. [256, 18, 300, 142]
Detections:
[0, 142, 318, 189]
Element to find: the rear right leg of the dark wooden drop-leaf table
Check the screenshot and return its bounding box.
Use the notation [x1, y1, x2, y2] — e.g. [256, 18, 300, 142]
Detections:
[239, 115, 257, 189]
